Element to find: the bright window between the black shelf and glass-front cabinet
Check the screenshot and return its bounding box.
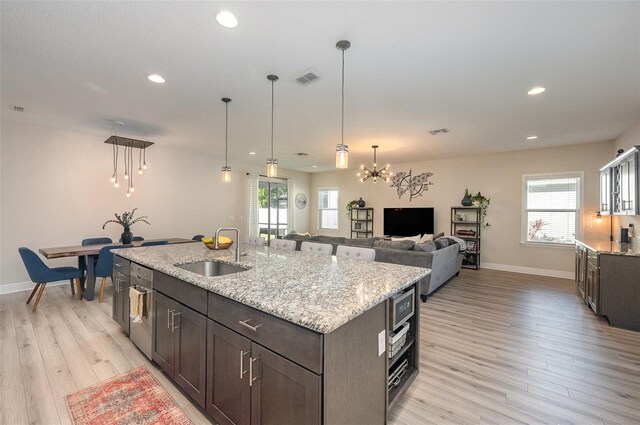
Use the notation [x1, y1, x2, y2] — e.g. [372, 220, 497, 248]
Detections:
[522, 173, 582, 245]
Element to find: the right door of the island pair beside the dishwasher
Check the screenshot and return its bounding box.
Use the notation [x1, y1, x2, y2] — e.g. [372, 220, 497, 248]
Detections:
[170, 304, 207, 407]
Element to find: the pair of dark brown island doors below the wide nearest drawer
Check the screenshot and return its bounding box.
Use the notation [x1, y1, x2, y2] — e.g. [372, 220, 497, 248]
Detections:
[206, 320, 321, 425]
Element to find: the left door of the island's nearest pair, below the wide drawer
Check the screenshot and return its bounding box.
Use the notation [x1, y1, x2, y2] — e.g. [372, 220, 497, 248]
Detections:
[206, 320, 251, 425]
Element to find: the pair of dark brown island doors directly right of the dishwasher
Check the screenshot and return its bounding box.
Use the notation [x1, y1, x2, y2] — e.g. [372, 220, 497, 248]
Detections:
[152, 291, 207, 407]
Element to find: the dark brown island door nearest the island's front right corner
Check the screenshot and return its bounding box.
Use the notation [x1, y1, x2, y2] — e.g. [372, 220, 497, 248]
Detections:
[250, 343, 321, 425]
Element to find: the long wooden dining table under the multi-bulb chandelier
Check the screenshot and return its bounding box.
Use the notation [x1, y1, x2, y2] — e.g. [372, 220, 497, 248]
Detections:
[38, 238, 196, 301]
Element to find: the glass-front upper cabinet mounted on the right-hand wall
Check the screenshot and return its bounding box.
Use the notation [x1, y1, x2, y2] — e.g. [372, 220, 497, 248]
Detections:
[600, 146, 640, 215]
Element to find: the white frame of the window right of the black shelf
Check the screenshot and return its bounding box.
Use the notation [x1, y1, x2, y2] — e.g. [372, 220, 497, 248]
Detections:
[520, 171, 584, 249]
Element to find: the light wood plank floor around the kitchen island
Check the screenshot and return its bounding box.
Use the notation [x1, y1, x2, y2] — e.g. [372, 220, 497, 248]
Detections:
[0, 270, 640, 425]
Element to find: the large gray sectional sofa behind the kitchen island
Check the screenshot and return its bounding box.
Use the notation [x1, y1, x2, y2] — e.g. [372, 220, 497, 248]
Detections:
[284, 234, 463, 301]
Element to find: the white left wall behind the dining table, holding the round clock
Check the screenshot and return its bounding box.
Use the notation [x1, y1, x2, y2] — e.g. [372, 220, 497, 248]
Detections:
[0, 120, 310, 285]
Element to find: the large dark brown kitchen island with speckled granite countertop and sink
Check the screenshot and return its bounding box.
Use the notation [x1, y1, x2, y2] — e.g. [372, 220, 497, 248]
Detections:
[114, 244, 430, 424]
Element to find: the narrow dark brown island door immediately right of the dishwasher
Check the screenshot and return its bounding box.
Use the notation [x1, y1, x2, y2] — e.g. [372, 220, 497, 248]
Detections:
[152, 291, 176, 377]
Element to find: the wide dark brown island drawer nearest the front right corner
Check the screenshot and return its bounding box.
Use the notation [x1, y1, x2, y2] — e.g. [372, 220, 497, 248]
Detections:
[209, 293, 323, 374]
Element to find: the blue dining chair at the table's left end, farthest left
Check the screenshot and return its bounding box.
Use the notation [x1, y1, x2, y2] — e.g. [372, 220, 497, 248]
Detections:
[18, 247, 82, 311]
